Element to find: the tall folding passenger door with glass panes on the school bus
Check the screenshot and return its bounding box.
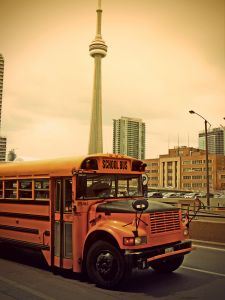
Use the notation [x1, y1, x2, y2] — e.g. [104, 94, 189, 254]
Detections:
[53, 177, 73, 269]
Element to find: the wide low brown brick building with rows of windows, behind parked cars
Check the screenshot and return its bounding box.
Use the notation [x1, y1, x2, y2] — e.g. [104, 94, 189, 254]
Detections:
[145, 146, 225, 192]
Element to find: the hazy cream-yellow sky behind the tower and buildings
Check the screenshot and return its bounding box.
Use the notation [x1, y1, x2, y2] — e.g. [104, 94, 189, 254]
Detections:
[0, 0, 225, 159]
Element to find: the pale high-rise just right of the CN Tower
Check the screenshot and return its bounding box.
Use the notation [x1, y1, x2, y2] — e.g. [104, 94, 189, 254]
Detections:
[113, 117, 145, 159]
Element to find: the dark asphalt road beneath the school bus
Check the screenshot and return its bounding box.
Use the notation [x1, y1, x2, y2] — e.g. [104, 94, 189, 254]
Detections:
[0, 242, 225, 300]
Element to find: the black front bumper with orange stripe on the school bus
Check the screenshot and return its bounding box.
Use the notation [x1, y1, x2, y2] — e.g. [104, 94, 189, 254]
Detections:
[125, 240, 193, 269]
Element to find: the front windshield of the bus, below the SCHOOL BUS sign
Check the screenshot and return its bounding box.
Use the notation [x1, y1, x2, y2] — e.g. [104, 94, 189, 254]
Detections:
[76, 174, 143, 199]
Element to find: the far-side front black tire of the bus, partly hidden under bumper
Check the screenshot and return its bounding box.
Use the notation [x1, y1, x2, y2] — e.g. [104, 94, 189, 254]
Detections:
[151, 255, 184, 273]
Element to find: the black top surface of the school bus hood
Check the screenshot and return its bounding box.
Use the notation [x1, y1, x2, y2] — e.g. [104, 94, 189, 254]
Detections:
[96, 199, 179, 213]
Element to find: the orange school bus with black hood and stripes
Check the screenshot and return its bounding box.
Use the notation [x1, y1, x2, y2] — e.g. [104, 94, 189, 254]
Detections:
[0, 154, 192, 288]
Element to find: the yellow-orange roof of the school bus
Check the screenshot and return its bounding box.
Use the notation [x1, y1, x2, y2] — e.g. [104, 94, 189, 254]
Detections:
[0, 154, 141, 177]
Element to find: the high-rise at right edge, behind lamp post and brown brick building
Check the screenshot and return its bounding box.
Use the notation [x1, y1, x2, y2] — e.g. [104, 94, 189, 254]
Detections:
[198, 128, 225, 155]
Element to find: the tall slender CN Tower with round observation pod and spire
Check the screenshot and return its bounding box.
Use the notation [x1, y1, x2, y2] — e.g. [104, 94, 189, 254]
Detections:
[88, 0, 107, 154]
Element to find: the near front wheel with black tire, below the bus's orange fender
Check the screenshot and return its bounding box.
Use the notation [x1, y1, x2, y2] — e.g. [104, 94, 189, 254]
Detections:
[86, 241, 131, 289]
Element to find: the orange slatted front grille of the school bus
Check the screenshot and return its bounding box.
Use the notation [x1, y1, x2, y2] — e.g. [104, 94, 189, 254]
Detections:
[150, 210, 180, 234]
